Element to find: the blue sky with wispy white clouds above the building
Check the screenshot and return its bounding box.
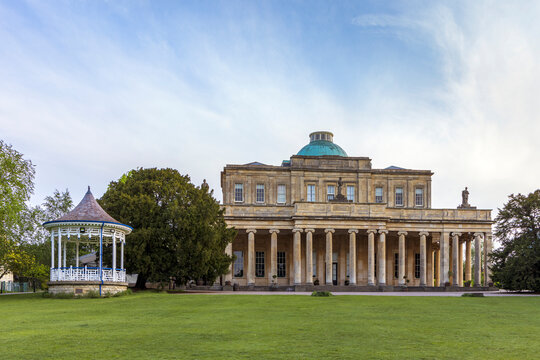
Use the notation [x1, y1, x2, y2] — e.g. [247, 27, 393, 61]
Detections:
[0, 0, 540, 215]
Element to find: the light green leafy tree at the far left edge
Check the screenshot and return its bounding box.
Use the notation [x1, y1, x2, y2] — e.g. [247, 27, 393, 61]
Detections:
[0, 140, 35, 277]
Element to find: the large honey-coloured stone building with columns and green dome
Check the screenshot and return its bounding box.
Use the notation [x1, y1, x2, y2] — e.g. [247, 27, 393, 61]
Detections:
[221, 131, 492, 289]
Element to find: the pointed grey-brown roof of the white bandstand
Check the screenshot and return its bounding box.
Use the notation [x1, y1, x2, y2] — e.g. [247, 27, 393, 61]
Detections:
[44, 186, 131, 228]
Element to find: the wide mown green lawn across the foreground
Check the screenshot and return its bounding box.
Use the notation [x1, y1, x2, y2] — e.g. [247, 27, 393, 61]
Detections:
[0, 293, 540, 359]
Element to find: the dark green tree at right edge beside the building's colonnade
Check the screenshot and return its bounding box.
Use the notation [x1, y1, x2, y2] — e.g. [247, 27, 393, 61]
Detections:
[491, 190, 540, 292]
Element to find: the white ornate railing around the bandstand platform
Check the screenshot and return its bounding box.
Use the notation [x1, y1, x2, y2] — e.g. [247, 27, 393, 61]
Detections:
[50, 266, 126, 282]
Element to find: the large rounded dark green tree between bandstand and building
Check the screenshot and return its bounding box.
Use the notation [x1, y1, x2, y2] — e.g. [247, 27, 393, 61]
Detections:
[99, 168, 236, 288]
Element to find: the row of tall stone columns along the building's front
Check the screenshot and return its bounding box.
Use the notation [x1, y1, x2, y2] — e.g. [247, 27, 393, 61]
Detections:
[225, 228, 491, 286]
